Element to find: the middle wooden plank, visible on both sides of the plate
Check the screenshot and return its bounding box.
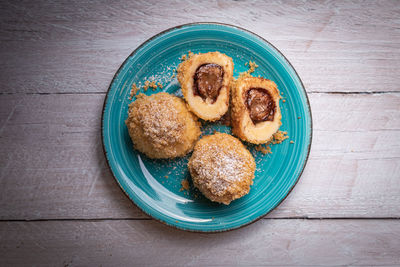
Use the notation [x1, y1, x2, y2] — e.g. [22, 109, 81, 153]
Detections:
[0, 94, 400, 220]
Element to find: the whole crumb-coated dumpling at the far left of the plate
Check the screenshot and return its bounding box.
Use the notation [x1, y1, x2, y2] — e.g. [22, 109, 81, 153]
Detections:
[125, 93, 201, 158]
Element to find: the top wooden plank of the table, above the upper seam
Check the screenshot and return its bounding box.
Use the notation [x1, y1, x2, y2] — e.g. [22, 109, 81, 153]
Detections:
[0, 0, 400, 93]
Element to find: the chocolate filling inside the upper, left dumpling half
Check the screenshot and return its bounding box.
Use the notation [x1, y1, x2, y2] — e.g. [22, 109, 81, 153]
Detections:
[193, 63, 224, 103]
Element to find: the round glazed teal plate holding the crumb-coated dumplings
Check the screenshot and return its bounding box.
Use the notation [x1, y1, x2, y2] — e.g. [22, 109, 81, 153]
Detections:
[102, 23, 312, 232]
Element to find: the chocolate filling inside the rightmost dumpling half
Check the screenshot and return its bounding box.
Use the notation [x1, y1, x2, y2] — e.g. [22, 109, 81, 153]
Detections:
[245, 88, 276, 124]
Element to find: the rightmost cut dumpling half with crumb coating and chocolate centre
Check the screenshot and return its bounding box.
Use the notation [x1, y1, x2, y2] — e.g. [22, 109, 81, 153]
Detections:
[231, 77, 282, 144]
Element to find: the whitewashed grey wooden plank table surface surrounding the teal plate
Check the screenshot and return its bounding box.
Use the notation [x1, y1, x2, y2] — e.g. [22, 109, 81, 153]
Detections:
[0, 0, 400, 266]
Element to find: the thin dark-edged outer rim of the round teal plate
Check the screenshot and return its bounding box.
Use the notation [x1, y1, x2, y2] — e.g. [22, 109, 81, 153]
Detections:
[100, 22, 313, 234]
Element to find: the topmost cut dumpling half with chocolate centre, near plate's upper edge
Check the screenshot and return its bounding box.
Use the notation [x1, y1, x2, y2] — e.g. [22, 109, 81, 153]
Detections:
[178, 52, 233, 121]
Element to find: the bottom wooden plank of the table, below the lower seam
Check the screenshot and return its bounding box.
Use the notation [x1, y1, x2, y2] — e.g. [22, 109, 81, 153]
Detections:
[0, 219, 400, 266]
